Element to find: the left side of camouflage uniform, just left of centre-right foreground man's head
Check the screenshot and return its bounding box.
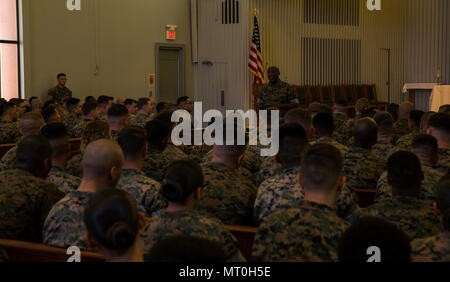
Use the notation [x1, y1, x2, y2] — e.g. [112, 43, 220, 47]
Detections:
[253, 167, 305, 225]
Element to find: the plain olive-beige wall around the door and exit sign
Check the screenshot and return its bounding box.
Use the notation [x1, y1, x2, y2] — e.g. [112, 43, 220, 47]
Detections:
[23, 0, 194, 100]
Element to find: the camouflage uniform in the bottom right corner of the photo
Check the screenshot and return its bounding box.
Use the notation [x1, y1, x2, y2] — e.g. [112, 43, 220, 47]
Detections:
[411, 231, 450, 262]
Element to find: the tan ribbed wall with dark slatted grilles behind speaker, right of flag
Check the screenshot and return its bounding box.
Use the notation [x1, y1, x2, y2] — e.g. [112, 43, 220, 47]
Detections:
[249, 0, 405, 101]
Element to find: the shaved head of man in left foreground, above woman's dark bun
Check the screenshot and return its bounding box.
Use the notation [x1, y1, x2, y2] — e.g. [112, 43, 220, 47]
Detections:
[81, 139, 124, 187]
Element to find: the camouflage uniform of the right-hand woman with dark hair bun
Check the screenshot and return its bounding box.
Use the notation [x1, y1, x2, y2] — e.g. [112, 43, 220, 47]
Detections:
[141, 210, 244, 258]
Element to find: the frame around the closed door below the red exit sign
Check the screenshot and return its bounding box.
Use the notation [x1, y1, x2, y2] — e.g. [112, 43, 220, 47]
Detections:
[155, 43, 186, 102]
